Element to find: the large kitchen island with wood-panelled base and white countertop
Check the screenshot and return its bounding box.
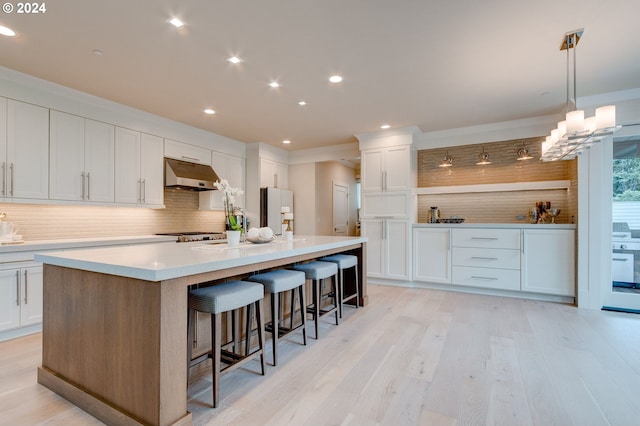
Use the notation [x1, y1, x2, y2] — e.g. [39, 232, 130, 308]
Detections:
[36, 236, 367, 425]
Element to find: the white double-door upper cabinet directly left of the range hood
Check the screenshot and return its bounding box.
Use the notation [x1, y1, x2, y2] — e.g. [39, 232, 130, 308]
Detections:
[115, 127, 164, 207]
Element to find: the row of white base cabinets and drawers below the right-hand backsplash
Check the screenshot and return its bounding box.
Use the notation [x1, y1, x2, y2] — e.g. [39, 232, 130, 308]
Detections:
[412, 226, 576, 297]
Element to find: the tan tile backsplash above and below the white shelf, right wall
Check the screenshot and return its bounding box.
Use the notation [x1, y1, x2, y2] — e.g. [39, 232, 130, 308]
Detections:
[418, 138, 578, 223]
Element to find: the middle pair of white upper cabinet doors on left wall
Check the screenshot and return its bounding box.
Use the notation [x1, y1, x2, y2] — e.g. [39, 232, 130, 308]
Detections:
[49, 110, 115, 203]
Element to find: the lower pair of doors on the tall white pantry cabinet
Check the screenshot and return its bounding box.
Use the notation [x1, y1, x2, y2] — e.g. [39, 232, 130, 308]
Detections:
[361, 218, 411, 281]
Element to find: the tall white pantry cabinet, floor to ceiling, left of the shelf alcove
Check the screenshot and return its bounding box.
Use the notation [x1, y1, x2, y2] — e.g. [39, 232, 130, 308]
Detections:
[357, 128, 417, 281]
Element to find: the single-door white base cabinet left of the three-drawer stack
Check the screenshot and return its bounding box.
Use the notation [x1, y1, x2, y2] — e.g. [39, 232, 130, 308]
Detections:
[413, 228, 451, 284]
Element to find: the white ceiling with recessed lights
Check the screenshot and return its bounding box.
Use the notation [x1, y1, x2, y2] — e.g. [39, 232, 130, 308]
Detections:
[0, 0, 640, 150]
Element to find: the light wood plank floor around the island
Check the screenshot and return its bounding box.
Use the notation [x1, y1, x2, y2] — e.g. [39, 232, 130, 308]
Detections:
[0, 285, 640, 426]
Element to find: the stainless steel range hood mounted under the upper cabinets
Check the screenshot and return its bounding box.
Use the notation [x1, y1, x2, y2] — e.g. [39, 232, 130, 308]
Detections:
[164, 158, 220, 191]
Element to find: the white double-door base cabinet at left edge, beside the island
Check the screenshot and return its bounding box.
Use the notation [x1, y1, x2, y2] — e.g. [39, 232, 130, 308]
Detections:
[0, 264, 42, 331]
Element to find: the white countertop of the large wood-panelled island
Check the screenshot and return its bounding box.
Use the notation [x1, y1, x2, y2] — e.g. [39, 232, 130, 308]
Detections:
[35, 236, 367, 281]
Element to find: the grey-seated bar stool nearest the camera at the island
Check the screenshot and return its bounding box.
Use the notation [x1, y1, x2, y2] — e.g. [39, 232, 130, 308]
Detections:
[187, 281, 265, 408]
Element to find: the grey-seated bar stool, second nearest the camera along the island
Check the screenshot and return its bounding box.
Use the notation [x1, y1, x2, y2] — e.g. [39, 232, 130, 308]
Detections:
[249, 269, 307, 366]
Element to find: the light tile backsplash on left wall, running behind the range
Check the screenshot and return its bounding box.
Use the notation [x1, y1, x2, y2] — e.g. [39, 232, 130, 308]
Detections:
[0, 189, 224, 241]
